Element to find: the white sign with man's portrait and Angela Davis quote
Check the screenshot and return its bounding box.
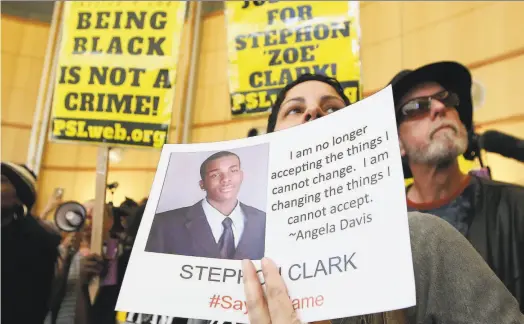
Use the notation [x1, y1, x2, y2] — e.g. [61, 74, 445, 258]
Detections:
[117, 87, 415, 323]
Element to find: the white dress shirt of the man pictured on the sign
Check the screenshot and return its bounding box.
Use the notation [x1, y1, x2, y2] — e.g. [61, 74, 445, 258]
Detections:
[202, 199, 245, 248]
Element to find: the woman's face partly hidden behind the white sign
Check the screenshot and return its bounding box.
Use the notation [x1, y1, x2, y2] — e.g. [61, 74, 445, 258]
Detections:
[275, 81, 346, 131]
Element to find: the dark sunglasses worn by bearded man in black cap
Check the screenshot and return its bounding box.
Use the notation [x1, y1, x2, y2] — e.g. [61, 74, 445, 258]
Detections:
[397, 90, 460, 122]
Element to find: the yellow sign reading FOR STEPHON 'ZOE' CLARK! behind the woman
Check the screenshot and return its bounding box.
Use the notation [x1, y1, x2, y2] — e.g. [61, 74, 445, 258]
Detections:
[225, 0, 361, 116]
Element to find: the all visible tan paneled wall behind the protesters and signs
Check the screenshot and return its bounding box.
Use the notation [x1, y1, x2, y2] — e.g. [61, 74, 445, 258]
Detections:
[2, 1, 524, 215]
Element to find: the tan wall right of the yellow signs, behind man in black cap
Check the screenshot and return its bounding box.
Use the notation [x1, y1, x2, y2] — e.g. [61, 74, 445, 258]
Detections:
[361, 1, 524, 185]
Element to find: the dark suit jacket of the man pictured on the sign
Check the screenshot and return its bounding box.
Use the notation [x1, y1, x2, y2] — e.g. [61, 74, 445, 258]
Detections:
[145, 201, 266, 260]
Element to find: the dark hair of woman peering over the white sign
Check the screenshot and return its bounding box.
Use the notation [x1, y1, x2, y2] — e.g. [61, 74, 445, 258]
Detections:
[267, 73, 351, 133]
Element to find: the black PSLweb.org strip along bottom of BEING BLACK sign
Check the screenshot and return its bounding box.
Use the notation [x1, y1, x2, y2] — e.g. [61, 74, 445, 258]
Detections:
[51, 118, 168, 148]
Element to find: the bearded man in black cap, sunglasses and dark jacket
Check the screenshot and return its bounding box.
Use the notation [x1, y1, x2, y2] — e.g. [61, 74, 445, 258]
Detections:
[390, 62, 524, 312]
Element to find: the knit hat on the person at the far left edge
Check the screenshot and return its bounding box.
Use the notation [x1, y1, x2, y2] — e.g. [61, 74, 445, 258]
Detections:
[2, 162, 36, 210]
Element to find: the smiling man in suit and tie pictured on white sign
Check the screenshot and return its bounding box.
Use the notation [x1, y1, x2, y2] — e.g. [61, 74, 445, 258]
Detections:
[145, 151, 266, 260]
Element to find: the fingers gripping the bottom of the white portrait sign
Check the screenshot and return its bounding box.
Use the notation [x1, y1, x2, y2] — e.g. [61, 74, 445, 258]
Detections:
[242, 258, 301, 324]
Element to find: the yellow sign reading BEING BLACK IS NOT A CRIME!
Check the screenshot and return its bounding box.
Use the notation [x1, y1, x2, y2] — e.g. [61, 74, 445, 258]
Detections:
[50, 1, 186, 148]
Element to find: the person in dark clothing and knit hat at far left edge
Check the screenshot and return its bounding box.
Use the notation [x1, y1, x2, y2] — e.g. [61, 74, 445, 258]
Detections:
[1, 162, 61, 324]
